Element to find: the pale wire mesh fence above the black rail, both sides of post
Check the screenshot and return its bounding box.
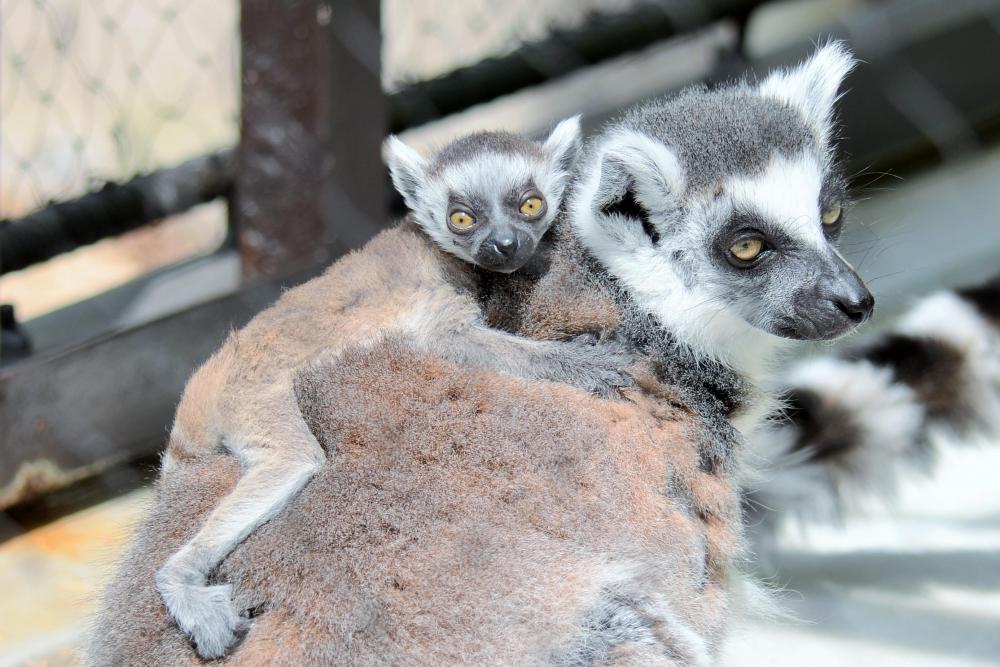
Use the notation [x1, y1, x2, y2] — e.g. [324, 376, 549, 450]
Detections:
[0, 0, 656, 217]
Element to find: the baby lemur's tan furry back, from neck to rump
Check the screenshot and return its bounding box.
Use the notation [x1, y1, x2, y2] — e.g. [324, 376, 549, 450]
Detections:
[168, 221, 475, 459]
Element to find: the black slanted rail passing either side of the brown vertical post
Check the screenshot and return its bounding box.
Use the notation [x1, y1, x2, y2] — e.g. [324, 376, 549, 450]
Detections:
[0, 0, 761, 274]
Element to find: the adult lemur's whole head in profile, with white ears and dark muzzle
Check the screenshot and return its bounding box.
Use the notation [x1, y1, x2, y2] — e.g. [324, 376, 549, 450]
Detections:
[571, 43, 874, 374]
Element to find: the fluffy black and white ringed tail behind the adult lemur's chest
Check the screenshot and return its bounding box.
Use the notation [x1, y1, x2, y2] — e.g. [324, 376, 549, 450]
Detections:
[745, 276, 1000, 533]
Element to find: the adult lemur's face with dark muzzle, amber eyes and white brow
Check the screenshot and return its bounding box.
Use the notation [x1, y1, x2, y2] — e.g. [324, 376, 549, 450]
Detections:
[692, 149, 875, 340]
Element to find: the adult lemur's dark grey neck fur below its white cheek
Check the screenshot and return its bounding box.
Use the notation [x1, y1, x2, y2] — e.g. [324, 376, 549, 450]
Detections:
[478, 217, 772, 446]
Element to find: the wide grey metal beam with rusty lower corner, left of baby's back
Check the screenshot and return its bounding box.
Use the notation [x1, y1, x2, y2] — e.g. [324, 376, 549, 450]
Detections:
[0, 282, 290, 508]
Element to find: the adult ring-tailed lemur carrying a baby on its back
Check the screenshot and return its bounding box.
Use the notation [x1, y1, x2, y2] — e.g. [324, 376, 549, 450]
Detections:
[88, 44, 996, 665]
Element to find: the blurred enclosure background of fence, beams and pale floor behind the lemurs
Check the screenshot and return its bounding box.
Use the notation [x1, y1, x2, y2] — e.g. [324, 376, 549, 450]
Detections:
[0, 0, 1000, 665]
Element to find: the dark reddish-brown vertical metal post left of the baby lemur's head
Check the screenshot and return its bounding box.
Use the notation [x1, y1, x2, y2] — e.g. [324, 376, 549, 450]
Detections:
[233, 0, 387, 277]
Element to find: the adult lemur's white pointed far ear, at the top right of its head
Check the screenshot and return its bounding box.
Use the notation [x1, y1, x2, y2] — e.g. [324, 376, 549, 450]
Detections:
[760, 41, 857, 148]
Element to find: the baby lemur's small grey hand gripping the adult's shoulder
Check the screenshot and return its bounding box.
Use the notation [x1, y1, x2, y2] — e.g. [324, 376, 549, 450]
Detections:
[550, 336, 635, 398]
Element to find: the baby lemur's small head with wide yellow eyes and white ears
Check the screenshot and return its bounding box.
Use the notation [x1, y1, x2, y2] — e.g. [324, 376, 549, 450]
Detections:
[386, 117, 580, 273]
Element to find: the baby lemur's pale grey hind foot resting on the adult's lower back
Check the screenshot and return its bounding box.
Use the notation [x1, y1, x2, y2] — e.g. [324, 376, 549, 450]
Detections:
[156, 572, 248, 660]
